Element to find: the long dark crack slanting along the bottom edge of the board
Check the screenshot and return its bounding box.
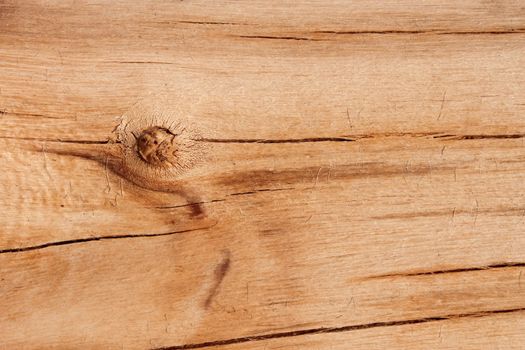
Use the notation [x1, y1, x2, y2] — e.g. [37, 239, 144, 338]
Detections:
[155, 307, 525, 350]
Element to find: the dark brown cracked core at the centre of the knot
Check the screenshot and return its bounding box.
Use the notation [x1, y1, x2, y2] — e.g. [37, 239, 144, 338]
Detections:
[137, 126, 180, 168]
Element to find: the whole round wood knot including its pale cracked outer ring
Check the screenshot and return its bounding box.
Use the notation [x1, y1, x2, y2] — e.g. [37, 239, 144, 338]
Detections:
[115, 104, 207, 190]
